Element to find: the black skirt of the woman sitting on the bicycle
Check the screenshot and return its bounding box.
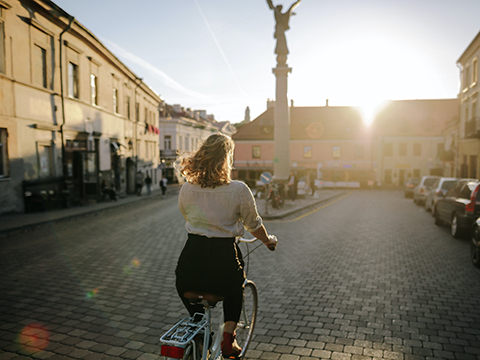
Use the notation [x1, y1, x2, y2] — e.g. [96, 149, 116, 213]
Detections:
[175, 234, 245, 297]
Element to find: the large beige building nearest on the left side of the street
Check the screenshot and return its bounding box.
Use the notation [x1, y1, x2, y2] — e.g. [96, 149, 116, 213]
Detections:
[0, 0, 162, 213]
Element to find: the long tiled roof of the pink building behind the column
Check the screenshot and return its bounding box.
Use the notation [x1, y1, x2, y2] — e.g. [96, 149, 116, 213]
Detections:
[233, 99, 459, 141]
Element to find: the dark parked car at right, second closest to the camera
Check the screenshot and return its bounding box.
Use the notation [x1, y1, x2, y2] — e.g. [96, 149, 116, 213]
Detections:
[433, 179, 480, 238]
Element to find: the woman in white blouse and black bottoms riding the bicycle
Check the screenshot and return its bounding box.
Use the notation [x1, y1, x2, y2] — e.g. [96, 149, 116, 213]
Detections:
[175, 133, 277, 357]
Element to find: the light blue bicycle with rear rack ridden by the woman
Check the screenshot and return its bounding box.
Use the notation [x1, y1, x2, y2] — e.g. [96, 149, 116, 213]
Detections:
[160, 235, 276, 360]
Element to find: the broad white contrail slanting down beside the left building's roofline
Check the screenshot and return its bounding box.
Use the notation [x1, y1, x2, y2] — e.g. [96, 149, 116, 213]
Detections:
[100, 38, 212, 102]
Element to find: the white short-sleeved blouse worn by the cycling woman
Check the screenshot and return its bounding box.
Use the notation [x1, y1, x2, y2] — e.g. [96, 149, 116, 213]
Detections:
[178, 180, 262, 237]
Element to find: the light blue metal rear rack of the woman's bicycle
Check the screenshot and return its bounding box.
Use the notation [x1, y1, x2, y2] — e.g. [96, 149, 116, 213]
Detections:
[160, 313, 207, 347]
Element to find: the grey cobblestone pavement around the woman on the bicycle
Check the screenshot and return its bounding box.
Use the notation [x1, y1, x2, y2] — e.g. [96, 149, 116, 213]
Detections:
[0, 190, 480, 360]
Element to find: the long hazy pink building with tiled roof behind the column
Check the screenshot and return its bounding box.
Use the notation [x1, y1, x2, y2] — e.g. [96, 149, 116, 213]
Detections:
[233, 99, 458, 187]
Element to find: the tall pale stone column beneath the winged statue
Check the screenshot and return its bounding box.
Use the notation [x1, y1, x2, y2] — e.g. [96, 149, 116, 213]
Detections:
[273, 64, 292, 181]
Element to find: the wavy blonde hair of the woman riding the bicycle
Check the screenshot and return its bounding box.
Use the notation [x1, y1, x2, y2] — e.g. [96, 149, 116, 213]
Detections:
[179, 133, 235, 188]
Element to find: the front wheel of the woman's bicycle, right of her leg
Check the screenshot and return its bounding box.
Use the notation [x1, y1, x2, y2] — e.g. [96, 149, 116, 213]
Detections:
[236, 280, 258, 358]
